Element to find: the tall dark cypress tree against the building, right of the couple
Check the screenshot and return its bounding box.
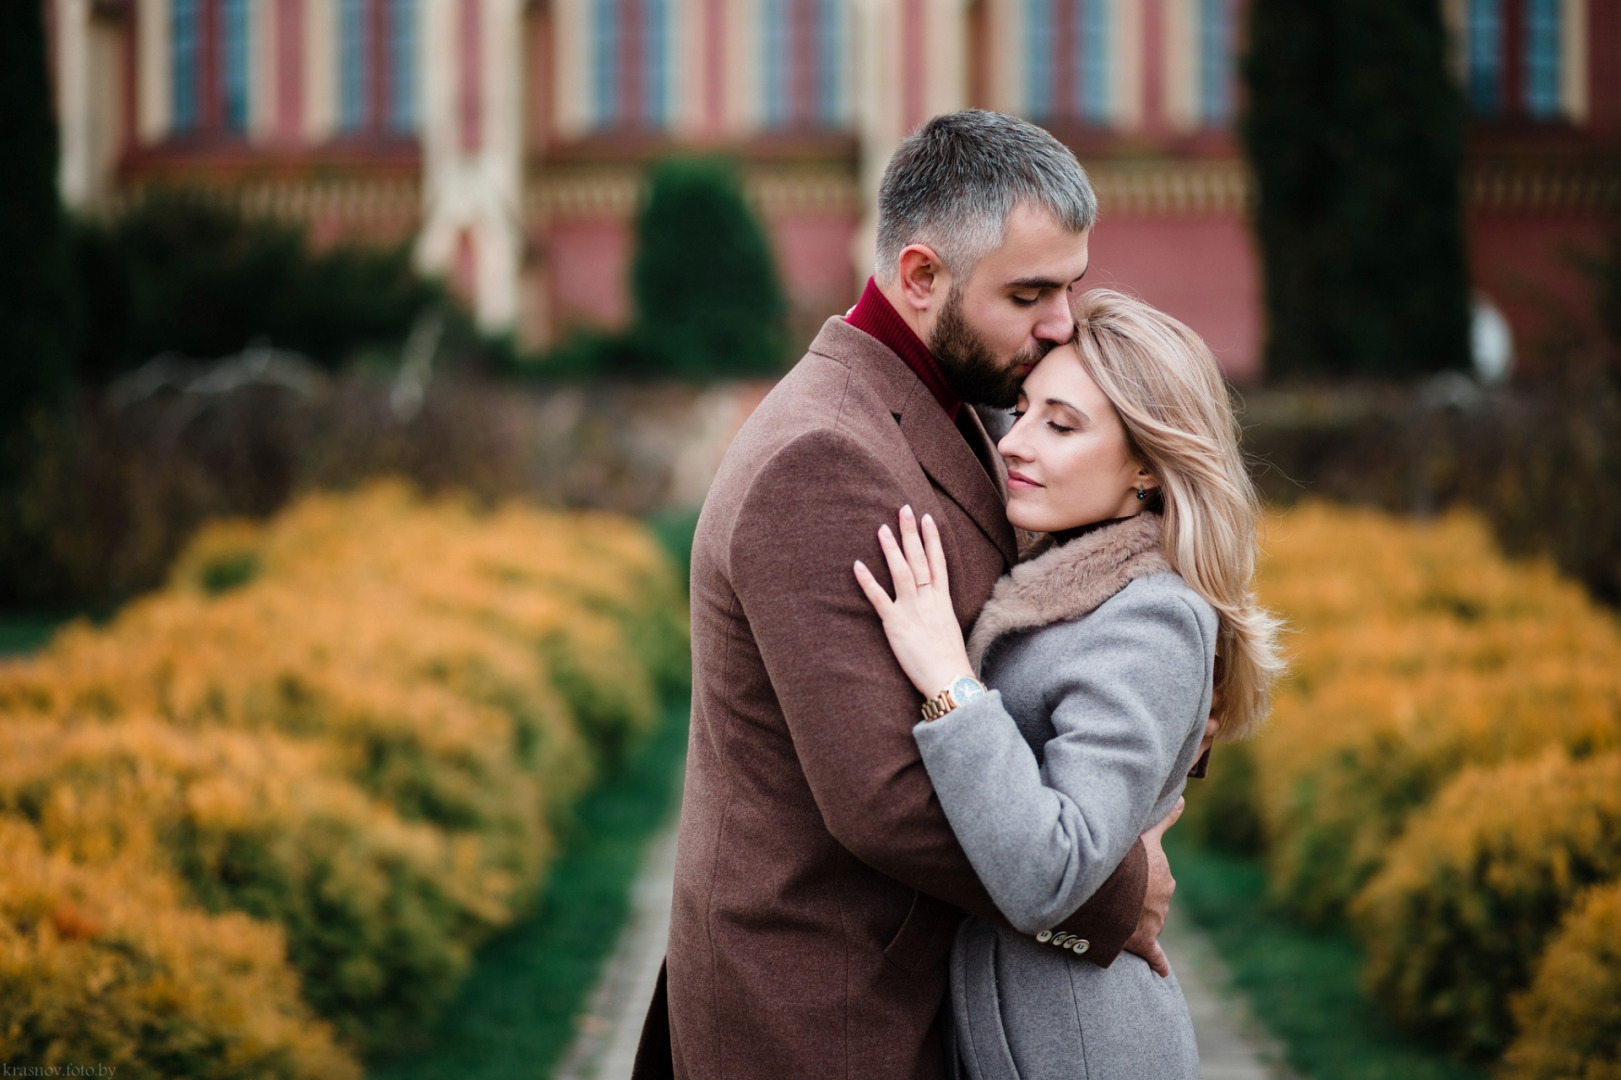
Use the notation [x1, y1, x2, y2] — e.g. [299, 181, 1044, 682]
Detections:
[1240, 0, 1469, 378]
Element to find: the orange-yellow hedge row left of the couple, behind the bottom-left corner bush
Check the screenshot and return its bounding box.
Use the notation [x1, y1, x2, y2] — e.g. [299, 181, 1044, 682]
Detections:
[0, 483, 687, 1051]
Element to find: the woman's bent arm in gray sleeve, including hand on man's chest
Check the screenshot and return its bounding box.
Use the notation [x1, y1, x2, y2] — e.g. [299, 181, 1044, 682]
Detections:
[856, 509, 1209, 932]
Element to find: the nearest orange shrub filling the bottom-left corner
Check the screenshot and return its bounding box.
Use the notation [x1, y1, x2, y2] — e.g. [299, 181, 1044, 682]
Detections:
[0, 817, 360, 1080]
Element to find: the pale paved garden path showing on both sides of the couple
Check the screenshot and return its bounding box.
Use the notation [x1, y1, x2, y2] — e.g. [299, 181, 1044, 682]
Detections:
[556, 807, 1302, 1080]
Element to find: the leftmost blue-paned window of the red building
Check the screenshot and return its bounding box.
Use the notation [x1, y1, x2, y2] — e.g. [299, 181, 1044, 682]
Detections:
[169, 0, 248, 133]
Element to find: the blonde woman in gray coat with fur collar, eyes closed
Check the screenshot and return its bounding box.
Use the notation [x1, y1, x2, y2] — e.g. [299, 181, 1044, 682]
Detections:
[856, 292, 1281, 1080]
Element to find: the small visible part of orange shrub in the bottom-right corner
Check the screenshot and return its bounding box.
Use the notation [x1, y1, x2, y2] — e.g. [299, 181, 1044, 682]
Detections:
[1501, 881, 1621, 1080]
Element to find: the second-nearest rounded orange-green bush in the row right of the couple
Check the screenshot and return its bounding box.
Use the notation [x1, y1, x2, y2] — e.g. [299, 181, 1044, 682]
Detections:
[1352, 749, 1621, 1056]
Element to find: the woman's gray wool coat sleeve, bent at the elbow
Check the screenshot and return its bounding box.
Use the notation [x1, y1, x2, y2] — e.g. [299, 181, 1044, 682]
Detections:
[914, 582, 1211, 934]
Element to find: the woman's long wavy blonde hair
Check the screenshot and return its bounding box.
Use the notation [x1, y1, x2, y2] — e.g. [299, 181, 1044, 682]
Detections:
[1073, 289, 1284, 738]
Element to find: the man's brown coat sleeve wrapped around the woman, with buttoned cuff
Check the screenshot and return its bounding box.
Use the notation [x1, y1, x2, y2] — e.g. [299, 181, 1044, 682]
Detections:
[728, 431, 1148, 965]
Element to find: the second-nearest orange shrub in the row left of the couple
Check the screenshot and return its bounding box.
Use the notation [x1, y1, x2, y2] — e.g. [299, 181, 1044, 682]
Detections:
[0, 718, 515, 1043]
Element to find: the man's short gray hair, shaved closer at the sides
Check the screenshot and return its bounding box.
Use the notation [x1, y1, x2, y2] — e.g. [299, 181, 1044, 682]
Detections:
[875, 109, 1097, 284]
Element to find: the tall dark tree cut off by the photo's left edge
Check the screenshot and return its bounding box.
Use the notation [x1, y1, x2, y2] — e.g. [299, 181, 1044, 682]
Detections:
[0, 0, 75, 443]
